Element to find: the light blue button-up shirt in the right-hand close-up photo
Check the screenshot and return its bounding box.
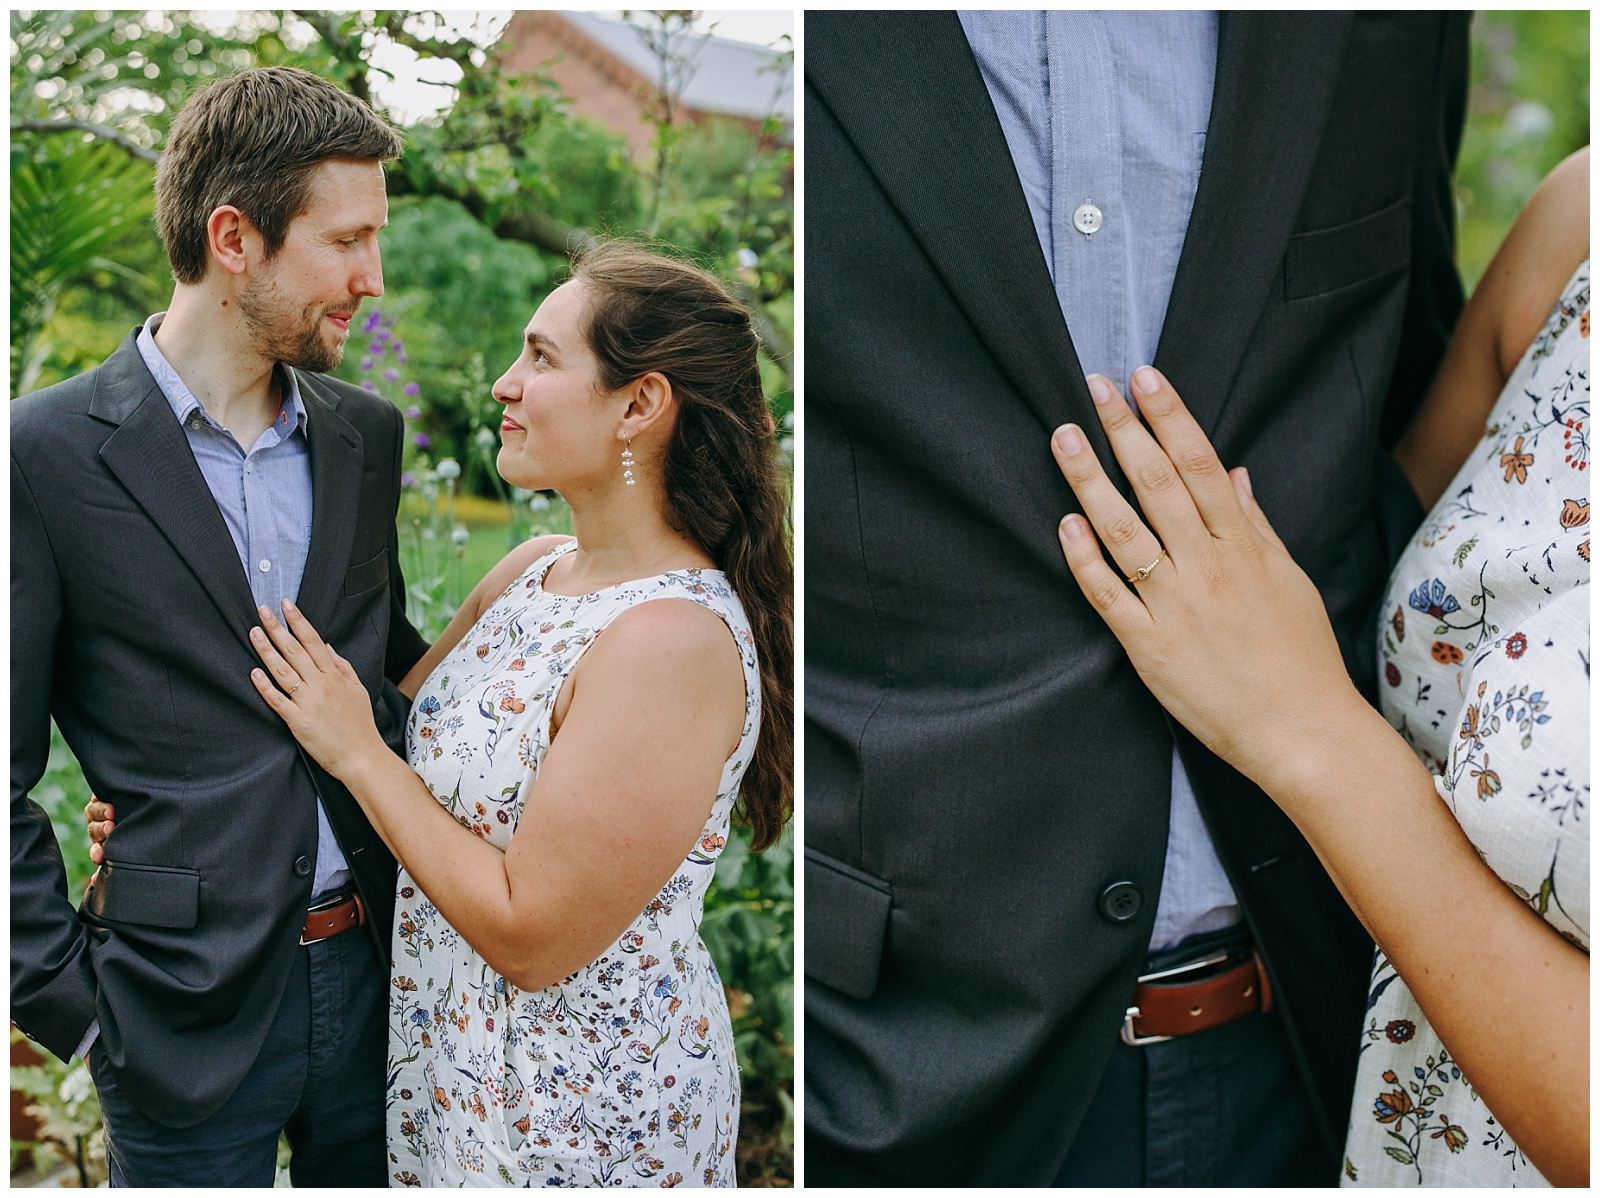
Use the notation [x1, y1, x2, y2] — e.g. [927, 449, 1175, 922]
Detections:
[960, 10, 1242, 950]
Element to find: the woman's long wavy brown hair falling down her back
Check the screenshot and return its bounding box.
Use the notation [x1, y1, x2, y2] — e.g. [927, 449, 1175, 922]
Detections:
[573, 242, 794, 849]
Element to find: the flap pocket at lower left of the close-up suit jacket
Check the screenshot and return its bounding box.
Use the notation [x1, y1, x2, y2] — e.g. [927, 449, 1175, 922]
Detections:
[805, 849, 894, 998]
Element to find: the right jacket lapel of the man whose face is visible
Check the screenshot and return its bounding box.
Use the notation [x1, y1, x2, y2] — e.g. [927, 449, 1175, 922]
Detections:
[294, 371, 362, 630]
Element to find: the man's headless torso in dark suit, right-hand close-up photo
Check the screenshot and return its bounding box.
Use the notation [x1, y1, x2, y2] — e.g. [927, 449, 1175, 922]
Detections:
[805, 11, 1466, 1185]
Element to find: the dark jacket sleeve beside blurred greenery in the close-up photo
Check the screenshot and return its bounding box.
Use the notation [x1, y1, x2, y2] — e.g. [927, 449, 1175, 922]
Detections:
[1379, 13, 1470, 448]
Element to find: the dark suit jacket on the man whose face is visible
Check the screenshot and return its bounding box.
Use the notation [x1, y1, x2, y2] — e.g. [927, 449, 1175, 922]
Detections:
[11, 333, 426, 1128]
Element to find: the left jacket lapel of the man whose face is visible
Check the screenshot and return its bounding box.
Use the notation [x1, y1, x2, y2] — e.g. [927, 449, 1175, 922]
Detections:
[90, 331, 258, 646]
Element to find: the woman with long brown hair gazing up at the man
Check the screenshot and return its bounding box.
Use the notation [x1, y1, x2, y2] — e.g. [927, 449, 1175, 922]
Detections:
[236, 246, 792, 1185]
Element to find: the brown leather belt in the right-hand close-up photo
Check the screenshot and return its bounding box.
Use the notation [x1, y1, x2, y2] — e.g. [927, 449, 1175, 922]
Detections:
[1122, 948, 1272, 1048]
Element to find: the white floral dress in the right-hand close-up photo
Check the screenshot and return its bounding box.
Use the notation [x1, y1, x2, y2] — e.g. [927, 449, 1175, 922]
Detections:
[1344, 261, 1589, 1187]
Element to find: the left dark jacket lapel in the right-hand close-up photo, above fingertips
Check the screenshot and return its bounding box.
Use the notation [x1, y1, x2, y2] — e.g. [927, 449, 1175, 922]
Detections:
[806, 11, 1109, 438]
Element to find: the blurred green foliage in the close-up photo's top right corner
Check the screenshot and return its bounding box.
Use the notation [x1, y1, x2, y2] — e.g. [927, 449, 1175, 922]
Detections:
[1456, 10, 1589, 291]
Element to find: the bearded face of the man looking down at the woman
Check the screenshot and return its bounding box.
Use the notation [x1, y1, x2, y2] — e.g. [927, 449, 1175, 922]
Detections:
[238, 160, 389, 371]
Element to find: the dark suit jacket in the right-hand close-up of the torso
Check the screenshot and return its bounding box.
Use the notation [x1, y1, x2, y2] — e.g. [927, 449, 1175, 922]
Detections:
[805, 11, 1466, 1185]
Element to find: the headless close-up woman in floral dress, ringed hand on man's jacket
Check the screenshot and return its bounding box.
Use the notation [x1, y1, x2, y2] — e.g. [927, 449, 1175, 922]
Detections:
[1053, 149, 1589, 1185]
